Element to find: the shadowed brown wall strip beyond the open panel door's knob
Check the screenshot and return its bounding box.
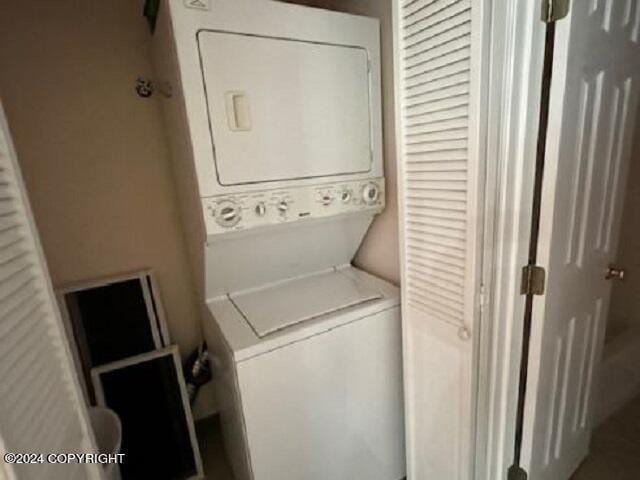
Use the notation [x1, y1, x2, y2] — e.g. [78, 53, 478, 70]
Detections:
[607, 112, 640, 337]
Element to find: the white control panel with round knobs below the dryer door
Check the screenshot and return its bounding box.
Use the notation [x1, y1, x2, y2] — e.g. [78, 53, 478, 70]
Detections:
[202, 178, 385, 235]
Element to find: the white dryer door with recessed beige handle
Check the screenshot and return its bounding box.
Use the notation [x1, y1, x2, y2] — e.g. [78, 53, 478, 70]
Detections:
[198, 31, 372, 185]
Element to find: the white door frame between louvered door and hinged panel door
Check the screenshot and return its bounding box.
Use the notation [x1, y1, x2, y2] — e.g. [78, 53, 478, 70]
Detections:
[475, 0, 546, 480]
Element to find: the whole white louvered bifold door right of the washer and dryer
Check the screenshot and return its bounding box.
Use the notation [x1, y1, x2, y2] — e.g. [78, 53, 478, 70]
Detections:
[394, 0, 486, 480]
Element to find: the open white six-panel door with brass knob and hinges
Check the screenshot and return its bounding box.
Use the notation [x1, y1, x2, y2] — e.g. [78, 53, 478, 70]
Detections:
[522, 0, 640, 480]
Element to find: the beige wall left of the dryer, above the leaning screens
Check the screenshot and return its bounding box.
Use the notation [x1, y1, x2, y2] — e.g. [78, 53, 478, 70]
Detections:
[0, 0, 200, 353]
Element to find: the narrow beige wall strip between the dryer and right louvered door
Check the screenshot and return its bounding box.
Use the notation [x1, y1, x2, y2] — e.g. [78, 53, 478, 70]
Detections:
[288, 0, 400, 284]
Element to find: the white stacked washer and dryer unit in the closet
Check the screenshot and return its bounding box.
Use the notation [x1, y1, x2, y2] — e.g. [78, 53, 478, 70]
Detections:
[154, 0, 405, 480]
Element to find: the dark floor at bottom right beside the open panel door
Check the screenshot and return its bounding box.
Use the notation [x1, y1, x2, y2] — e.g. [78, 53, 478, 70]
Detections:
[571, 397, 640, 480]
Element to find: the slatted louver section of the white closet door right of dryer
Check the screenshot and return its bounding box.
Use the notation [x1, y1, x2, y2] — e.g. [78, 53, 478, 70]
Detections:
[399, 0, 472, 326]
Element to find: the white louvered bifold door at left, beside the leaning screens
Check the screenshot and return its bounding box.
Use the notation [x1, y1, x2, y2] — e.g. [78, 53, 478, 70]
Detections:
[0, 104, 99, 480]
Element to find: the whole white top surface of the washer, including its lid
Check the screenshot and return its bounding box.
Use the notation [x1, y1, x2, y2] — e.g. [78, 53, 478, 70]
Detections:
[205, 265, 400, 361]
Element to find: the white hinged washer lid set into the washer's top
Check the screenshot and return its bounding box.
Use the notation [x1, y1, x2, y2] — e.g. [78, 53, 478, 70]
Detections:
[229, 270, 383, 338]
